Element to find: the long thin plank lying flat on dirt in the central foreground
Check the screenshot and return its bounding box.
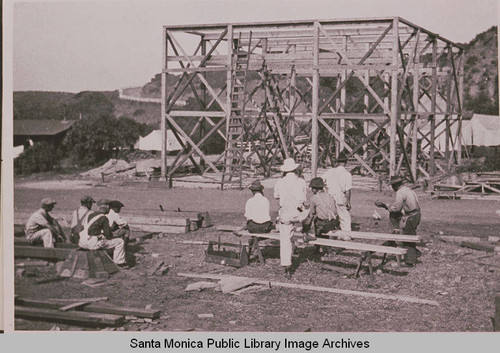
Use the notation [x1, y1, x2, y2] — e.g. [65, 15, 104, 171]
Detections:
[177, 273, 439, 306]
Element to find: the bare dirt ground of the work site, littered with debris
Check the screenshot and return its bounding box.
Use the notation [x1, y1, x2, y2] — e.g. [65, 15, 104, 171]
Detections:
[10, 180, 500, 332]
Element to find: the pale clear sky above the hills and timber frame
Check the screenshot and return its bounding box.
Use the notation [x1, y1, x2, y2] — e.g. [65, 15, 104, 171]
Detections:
[9, 0, 498, 92]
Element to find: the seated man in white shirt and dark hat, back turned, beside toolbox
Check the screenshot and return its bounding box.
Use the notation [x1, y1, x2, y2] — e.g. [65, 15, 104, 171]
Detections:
[245, 180, 273, 233]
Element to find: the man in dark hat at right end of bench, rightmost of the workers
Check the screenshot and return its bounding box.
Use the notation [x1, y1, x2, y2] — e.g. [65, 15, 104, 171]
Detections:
[375, 177, 421, 265]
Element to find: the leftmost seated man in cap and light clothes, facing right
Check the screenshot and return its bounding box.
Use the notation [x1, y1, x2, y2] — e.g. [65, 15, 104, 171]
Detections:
[26, 198, 66, 248]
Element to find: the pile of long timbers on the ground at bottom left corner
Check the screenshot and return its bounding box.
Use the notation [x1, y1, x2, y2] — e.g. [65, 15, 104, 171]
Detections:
[15, 297, 161, 327]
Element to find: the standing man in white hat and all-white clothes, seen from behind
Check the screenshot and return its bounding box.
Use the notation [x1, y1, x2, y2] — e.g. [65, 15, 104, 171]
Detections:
[274, 158, 308, 278]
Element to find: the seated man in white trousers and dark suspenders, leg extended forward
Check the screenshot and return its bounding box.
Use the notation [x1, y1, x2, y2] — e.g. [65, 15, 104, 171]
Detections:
[78, 200, 127, 267]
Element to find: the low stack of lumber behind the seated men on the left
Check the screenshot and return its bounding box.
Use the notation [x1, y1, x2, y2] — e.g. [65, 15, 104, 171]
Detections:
[14, 210, 212, 234]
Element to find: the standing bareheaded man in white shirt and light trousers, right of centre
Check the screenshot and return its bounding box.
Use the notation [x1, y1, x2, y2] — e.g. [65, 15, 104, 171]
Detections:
[323, 156, 352, 231]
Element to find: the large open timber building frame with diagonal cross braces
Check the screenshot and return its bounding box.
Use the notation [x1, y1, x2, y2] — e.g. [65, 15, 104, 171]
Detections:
[161, 17, 464, 188]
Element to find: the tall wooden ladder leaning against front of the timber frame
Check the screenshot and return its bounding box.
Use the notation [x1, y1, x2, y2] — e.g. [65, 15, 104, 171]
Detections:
[221, 32, 252, 189]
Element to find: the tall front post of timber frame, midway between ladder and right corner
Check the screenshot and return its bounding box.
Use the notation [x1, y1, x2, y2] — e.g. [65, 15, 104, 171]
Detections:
[311, 21, 319, 178]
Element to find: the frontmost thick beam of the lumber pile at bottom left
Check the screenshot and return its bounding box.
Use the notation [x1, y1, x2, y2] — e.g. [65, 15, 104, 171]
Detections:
[15, 305, 124, 326]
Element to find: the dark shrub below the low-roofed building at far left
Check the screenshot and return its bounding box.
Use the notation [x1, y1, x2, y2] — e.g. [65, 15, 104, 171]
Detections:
[14, 142, 59, 175]
